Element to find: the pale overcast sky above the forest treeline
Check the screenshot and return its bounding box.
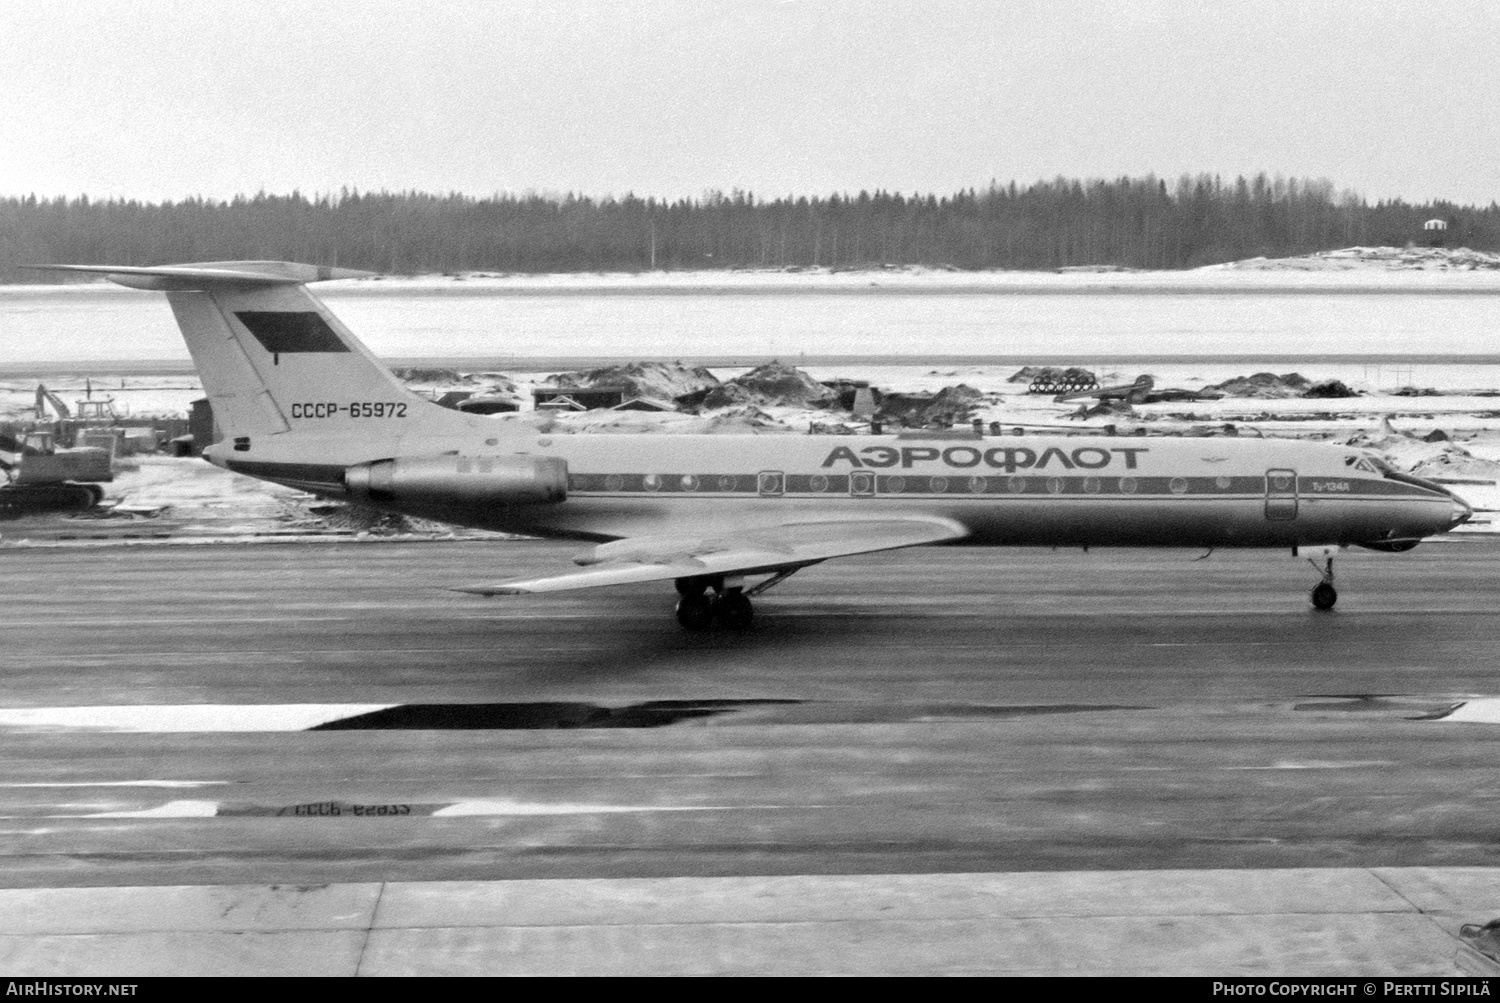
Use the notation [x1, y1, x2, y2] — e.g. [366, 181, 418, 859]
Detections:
[0, 0, 1500, 204]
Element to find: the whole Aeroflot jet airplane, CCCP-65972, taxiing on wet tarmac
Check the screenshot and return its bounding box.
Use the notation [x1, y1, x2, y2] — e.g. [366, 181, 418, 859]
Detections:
[29, 261, 1473, 631]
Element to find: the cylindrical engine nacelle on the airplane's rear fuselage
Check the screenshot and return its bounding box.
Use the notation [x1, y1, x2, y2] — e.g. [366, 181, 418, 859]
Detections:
[344, 454, 567, 508]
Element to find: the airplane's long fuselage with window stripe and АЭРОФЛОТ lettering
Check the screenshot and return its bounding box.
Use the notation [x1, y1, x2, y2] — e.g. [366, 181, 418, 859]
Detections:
[224, 420, 1469, 547]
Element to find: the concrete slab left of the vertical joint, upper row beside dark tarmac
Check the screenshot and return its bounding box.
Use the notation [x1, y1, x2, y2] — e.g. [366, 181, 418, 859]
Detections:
[0, 882, 380, 935]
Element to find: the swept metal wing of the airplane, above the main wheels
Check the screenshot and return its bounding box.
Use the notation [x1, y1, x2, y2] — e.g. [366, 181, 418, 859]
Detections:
[455, 517, 969, 595]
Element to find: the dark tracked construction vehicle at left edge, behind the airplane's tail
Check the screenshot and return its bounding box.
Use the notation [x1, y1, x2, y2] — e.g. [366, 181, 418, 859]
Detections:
[0, 429, 114, 516]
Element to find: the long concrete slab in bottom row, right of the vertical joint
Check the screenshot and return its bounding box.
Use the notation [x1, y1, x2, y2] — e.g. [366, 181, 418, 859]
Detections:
[360, 915, 1457, 976]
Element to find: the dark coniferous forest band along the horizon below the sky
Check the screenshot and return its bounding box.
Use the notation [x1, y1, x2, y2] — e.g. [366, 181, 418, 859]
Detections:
[0, 174, 1500, 282]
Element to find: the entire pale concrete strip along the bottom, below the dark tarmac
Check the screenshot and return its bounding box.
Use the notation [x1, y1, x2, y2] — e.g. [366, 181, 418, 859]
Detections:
[0, 868, 1500, 976]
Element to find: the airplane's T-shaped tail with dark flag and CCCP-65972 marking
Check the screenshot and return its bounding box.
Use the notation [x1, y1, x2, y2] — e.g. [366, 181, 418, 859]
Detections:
[33, 261, 465, 436]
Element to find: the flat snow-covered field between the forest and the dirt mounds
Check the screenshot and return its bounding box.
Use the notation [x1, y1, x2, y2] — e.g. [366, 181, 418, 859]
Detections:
[0, 249, 1500, 364]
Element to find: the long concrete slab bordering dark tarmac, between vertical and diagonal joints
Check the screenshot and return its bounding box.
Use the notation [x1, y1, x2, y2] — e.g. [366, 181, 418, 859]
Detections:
[375, 868, 1404, 928]
